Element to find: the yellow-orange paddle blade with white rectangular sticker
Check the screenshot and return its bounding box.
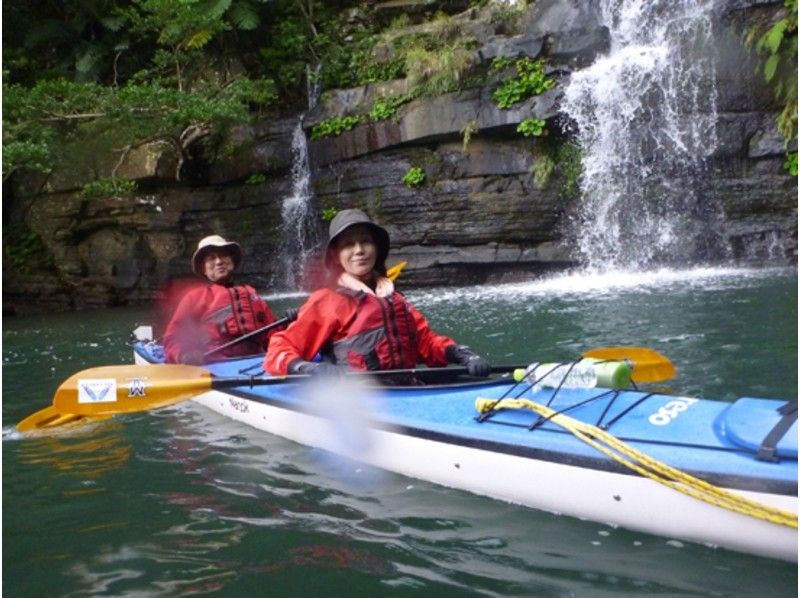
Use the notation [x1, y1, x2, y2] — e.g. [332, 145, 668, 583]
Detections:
[53, 364, 216, 415]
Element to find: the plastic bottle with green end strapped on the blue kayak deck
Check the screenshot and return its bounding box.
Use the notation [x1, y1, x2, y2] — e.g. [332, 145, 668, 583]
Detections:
[514, 357, 631, 392]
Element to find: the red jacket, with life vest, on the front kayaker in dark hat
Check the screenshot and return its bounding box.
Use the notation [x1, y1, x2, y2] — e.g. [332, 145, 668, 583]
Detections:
[264, 289, 455, 376]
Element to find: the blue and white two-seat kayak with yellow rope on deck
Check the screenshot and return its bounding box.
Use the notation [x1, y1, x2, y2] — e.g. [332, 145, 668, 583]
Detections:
[133, 338, 798, 561]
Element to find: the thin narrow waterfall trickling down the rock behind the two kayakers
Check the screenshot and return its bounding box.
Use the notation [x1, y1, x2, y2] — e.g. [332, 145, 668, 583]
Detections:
[274, 67, 320, 291]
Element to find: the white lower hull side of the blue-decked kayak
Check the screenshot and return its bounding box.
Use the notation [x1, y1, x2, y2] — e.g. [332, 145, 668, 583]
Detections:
[194, 391, 798, 561]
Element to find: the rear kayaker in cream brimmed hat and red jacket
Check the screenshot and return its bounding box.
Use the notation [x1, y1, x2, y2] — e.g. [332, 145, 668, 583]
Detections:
[164, 235, 296, 365]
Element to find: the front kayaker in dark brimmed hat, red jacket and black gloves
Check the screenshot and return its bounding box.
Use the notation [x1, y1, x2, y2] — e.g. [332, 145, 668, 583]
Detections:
[264, 210, 491, 376]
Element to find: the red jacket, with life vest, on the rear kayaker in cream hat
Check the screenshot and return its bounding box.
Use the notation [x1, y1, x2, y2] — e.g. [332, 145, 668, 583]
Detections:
[164, 283, 277, 363]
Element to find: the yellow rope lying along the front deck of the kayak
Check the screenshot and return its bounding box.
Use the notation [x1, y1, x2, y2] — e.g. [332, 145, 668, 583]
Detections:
[475, 398, 797, 529]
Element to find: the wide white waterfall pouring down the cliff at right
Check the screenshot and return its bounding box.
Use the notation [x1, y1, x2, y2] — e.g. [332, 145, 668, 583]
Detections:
[562, 0, 725, 270]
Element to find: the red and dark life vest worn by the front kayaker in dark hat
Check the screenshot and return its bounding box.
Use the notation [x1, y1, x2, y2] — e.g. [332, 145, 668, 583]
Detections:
[324, 289, 418, 370]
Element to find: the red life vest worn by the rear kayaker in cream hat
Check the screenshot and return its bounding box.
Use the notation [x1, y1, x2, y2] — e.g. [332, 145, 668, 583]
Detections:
[203, 284, 269, 340]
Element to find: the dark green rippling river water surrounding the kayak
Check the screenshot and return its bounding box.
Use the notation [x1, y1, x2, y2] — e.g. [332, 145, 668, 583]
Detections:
[2, 269, 798, 597]
